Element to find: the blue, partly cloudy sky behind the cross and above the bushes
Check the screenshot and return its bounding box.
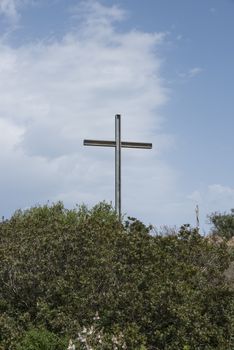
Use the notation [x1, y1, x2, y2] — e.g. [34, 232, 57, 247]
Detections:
[0, 0, 234, 233]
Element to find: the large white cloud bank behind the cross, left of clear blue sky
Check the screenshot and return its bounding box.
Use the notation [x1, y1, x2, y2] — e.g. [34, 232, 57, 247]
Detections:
[0, 1, 175, 224]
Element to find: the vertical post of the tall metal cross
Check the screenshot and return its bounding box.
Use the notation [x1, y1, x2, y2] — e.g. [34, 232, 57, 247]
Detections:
[115, 114, 121, 217]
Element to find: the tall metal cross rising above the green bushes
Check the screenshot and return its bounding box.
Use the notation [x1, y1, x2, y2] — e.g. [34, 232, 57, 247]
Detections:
[84, 114, 152, 218]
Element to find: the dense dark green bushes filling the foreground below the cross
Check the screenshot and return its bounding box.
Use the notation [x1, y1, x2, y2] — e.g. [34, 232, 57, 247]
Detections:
[0, 203, 233, 350]
